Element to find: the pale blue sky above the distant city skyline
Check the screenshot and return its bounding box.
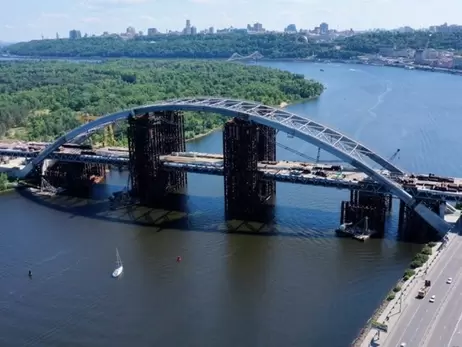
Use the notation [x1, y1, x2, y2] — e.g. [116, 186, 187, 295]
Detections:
[0, 0, 462, 42]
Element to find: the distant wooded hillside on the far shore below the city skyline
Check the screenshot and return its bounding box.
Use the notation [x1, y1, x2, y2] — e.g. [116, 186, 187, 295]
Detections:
[4, 31, 462, 59]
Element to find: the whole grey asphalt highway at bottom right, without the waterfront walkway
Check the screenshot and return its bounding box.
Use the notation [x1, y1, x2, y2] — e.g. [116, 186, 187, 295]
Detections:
[380, 236, 462, 347]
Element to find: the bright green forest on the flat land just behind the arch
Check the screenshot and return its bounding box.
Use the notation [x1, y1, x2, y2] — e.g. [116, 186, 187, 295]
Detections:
[0, 59, 323, 144]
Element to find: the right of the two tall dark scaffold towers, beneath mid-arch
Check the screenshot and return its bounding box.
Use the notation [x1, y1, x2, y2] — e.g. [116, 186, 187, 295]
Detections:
[223, 118, 276, 220]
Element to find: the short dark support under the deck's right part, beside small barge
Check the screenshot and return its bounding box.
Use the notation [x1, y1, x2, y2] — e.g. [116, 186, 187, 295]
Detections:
[340, 190, 392, 235]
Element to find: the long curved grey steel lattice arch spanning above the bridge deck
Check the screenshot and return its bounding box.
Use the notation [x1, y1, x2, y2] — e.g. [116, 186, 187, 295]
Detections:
[19, 97, 449, 233]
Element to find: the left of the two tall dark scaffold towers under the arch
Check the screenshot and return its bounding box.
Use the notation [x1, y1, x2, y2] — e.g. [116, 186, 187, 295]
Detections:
[128, 112, 186, 207]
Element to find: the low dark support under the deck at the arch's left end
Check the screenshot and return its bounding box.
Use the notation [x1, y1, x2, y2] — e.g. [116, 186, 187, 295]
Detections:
[42, 161, 106, 197]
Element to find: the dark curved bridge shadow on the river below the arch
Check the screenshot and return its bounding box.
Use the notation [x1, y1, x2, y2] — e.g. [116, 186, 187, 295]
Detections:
[18, 188, 352, 238]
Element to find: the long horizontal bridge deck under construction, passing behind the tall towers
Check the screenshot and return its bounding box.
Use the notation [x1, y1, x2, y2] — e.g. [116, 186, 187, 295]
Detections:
[0, 143, 462, 201]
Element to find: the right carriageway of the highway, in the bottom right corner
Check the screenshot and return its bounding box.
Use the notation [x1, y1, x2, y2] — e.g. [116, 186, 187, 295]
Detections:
[423, 254, 462, 347]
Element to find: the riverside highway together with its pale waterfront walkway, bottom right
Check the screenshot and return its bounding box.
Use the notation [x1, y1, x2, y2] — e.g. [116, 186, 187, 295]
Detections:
[361, 223, 462, 347]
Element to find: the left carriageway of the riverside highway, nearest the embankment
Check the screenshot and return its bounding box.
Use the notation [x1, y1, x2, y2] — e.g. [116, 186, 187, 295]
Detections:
[380, 237, 462, 347]
